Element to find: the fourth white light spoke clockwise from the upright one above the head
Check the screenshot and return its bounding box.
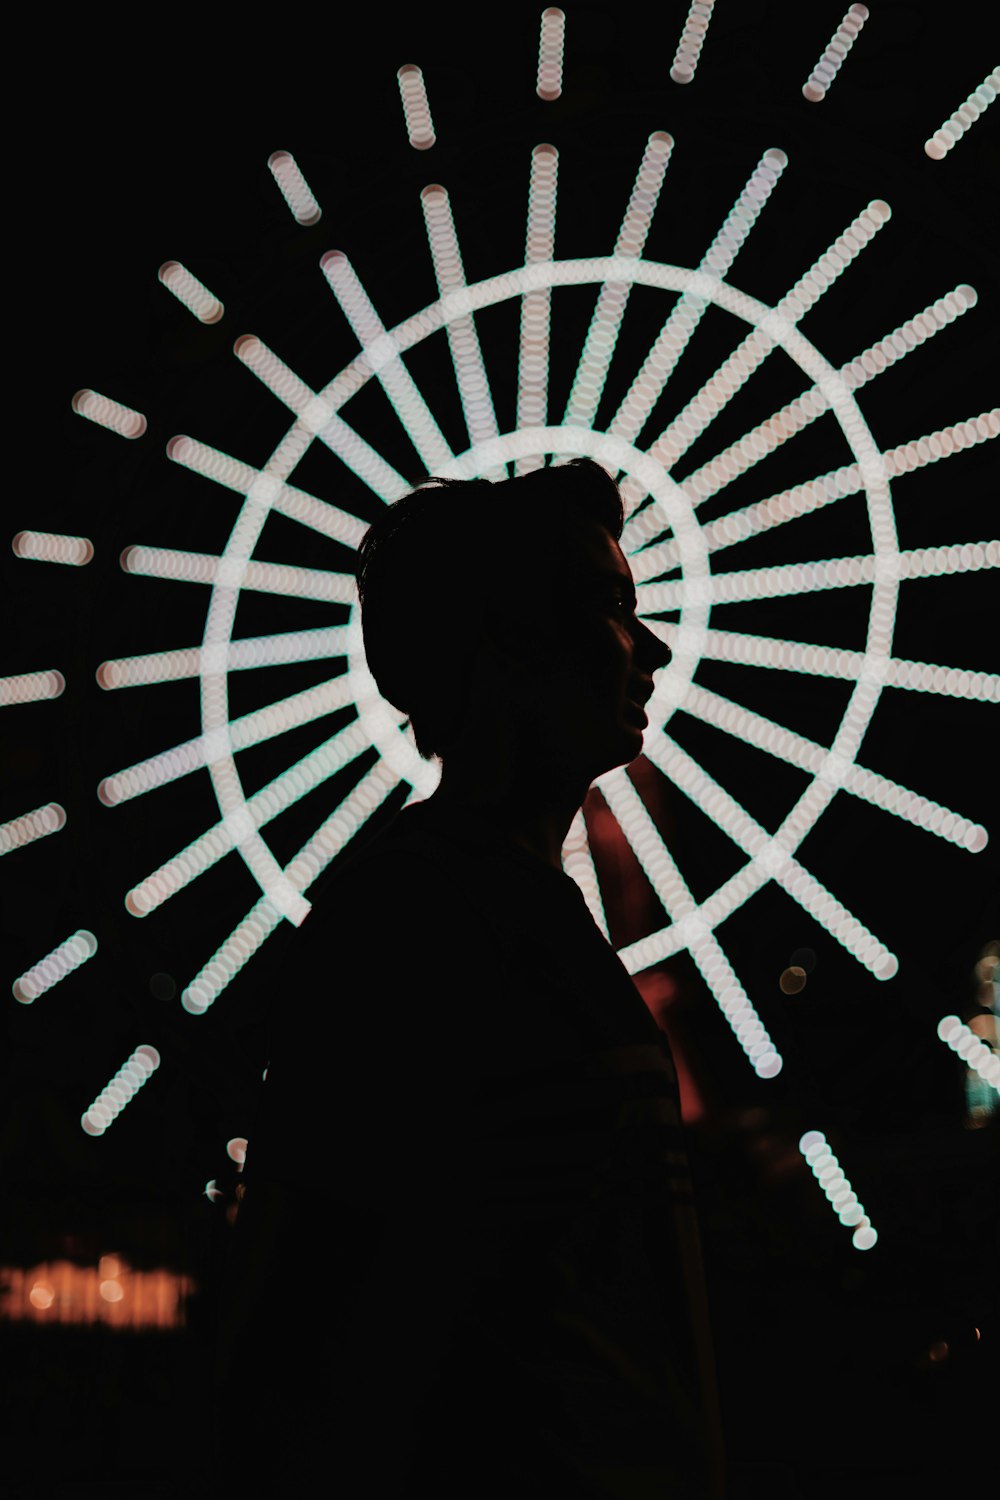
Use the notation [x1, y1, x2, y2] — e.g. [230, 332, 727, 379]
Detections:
[681, 285, 978, 506]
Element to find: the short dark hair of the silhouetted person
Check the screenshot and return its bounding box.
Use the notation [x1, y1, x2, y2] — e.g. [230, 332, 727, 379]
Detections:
[355, 458, 624, 759]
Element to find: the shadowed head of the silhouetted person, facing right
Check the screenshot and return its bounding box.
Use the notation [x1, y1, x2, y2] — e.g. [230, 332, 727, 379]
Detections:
[357, 459, 670, 779]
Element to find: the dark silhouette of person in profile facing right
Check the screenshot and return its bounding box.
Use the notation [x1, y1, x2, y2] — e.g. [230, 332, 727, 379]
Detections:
[219, 459, 723, 1500]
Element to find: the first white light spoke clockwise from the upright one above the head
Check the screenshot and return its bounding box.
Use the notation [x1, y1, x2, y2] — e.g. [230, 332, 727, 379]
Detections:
[562, 131, 673, 438]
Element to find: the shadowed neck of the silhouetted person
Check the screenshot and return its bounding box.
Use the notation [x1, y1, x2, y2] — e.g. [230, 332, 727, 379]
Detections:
[426, 761, 586, 870]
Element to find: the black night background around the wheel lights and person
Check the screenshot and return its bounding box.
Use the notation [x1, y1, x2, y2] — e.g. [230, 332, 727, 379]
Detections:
[0, 0, 1000, 1496]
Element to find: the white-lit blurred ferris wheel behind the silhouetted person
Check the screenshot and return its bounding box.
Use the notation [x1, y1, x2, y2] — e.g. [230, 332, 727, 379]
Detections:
[4, 3, 1000, 1248]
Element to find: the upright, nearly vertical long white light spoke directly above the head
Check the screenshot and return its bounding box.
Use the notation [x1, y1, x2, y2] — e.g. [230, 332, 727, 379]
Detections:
[514, 143, 559, 474]
